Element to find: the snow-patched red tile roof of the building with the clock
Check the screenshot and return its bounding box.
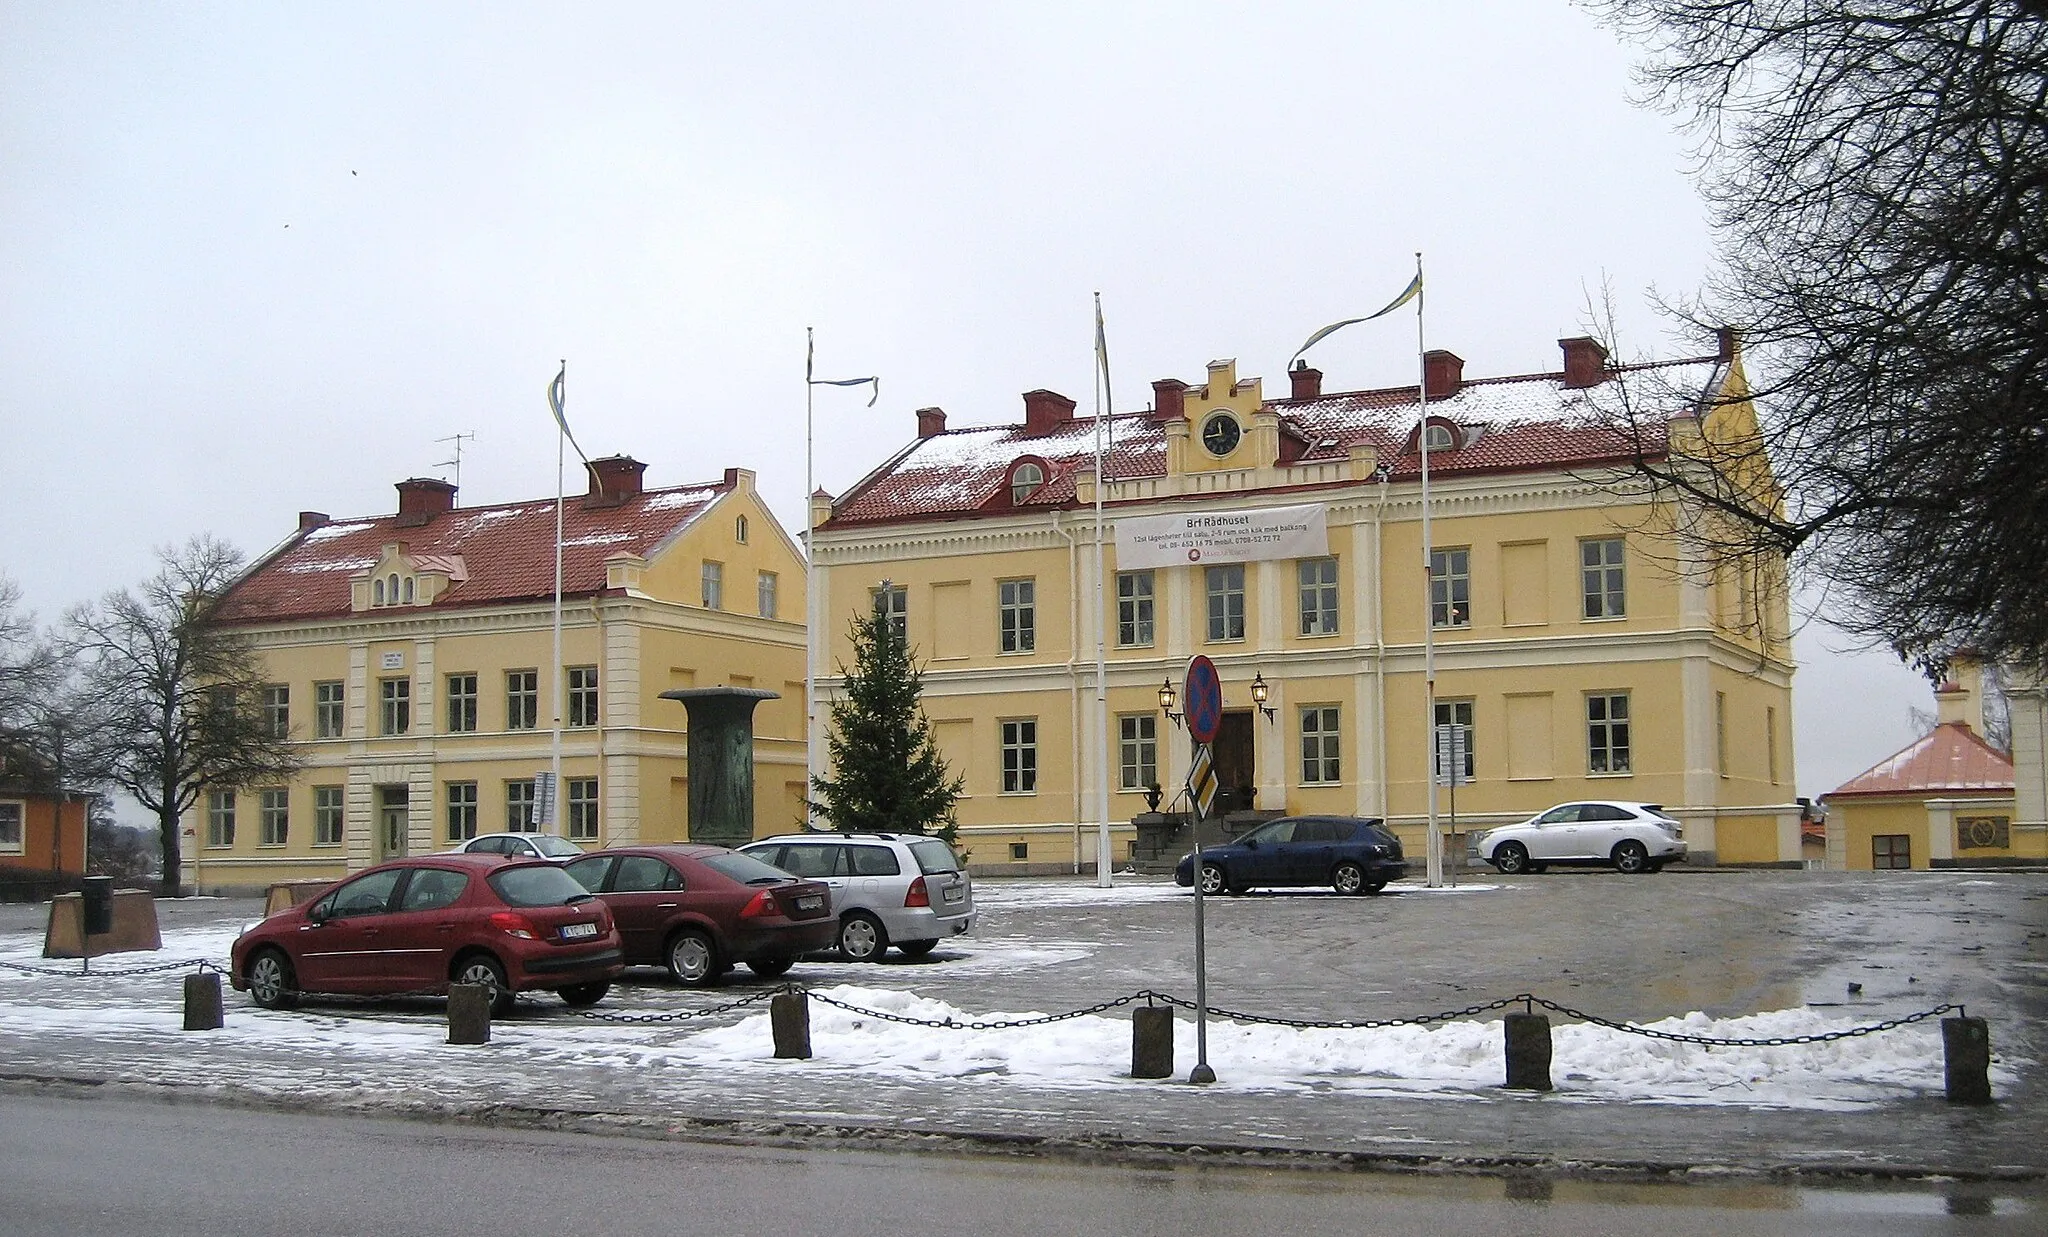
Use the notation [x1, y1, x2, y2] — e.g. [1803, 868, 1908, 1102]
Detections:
[831, 358, 1729, 526]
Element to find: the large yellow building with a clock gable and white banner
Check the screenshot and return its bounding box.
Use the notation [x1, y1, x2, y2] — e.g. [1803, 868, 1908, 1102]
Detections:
[811, 334, 1800, 868]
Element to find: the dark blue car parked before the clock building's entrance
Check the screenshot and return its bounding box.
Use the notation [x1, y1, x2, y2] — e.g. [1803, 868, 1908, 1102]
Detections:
[1174, 815, 1407, 893]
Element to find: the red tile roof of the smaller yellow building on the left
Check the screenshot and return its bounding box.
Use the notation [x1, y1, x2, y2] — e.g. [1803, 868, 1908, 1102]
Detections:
[219, 481, 733, 623]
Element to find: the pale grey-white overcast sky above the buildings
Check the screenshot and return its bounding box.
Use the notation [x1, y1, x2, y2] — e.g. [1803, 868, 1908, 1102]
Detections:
[0, 0, 1929, 795]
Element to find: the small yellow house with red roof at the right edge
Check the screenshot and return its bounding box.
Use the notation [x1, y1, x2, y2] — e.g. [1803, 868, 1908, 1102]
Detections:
[1825, 659, 2048, 870]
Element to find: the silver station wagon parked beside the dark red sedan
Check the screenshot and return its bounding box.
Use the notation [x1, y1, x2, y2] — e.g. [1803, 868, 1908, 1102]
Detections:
[739, 834, 975, 963]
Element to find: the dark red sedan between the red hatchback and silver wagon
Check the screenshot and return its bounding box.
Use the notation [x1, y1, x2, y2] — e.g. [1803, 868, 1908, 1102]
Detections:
[561, 842, 840, 987]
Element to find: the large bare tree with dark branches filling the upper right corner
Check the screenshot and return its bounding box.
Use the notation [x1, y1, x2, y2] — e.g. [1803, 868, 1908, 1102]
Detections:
[1587, 0, 2048, 674]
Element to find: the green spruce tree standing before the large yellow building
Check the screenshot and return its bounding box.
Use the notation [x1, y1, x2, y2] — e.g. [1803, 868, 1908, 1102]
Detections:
[811, 610, 961, 842]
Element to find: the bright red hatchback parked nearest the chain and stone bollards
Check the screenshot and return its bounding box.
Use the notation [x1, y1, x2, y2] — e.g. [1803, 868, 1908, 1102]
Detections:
[229, 854, 623, 1018]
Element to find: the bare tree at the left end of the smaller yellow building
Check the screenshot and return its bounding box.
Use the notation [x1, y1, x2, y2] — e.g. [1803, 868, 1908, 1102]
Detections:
[63, 537, 299, 897]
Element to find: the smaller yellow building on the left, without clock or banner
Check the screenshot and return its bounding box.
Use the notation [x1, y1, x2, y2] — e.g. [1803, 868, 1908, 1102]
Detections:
[184, 457, 805, 889]
